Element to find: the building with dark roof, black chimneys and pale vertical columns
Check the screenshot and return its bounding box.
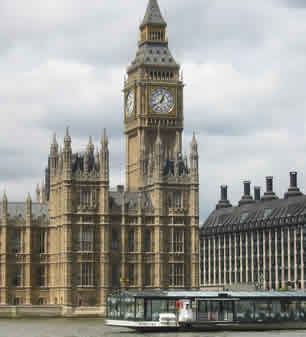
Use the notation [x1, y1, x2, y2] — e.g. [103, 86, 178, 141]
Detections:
[200, 172, 306, 289]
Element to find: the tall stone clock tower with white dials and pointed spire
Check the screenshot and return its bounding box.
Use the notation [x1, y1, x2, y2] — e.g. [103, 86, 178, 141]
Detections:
[123, 0, 184, 191]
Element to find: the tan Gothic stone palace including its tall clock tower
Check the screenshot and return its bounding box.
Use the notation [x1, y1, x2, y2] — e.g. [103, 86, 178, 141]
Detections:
[0, 0, 199, 307]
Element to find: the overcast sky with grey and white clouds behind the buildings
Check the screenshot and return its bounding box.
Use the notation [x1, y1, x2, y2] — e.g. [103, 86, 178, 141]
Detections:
[0, 0, 306, 221]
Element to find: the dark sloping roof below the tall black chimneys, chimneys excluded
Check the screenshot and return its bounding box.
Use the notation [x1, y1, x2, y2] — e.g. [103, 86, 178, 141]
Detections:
[201, 195, 306, 234]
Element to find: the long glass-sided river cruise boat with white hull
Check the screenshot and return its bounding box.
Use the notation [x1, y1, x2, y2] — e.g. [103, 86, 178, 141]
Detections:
[105, 291, 306, 331]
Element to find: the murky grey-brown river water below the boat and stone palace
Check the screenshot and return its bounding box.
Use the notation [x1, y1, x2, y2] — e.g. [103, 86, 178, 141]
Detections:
[0, 319, 306, 337]
